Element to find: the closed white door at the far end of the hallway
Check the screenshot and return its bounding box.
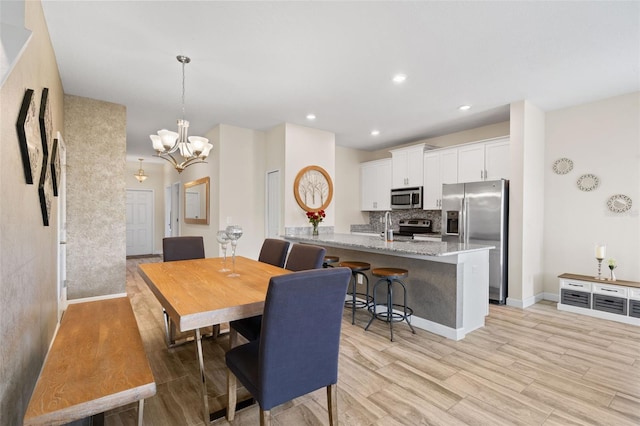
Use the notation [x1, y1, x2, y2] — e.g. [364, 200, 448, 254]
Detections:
[127, 189, 153, 256]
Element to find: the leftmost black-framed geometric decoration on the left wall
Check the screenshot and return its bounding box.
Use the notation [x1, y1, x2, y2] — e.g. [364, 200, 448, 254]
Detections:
[16, 89, 43, 184]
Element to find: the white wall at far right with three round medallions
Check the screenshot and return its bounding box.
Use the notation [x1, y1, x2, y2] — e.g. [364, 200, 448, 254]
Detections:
[544, 92, 640, 294]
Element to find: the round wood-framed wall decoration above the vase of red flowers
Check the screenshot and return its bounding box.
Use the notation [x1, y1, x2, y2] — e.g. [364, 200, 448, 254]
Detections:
[293, 166, 333, 212]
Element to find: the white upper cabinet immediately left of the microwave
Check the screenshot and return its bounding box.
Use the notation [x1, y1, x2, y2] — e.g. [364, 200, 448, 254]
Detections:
[360, 158, 391, 211]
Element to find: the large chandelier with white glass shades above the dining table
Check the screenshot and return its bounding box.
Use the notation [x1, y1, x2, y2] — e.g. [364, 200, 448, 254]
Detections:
[150, 55, 213, 173]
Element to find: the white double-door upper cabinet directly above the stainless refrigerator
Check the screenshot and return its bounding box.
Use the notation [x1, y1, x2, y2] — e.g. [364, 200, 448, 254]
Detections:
[458, 138, 509, 183]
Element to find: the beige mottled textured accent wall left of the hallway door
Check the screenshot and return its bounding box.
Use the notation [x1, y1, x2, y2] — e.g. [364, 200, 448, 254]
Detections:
[64, 95, 127, 299]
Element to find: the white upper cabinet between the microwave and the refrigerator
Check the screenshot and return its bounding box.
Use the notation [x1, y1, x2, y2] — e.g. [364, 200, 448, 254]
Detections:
[422, 148, 458, 210]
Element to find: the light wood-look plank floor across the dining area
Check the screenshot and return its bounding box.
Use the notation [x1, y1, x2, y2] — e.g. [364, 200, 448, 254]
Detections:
[105, 258, 640, 426]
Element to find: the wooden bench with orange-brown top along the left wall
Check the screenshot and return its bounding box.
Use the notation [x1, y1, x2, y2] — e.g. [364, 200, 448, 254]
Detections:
[24, 297, 156, 425]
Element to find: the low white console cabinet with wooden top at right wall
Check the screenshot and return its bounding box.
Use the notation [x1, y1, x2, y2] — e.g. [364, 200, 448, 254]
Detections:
[558, 274, 640, 325]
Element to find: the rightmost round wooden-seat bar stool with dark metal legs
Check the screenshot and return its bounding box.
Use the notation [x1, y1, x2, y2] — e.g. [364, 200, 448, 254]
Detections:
[365, 268, 416, 342]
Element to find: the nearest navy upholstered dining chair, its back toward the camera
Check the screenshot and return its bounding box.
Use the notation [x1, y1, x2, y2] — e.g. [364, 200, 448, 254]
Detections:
[225, 268, 351, 425]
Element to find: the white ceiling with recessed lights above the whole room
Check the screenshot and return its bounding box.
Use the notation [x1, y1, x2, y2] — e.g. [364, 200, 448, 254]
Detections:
[42, 0, 640, 159]
